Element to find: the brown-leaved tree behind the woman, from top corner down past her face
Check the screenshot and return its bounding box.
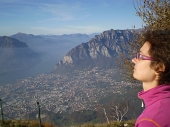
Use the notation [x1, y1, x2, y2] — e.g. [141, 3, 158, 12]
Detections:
[118, 0, 170, 81]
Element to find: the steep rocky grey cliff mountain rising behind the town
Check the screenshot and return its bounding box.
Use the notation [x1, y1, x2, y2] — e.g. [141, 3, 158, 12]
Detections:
[55, 29, 133, 71]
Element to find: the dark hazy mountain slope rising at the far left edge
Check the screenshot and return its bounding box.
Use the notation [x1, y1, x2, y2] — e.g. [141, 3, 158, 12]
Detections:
[0, 36, 41, 73]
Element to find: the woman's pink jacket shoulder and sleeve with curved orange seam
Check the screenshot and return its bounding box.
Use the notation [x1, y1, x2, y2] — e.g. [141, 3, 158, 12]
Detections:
[135, 98, 170, 127]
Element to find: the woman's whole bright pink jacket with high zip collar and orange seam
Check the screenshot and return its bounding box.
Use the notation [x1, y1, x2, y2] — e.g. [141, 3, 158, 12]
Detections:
[135, 85, 170, 127]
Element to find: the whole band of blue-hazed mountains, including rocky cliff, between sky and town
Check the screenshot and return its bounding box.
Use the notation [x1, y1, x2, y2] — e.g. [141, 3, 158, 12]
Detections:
[0, 29, 136, 83]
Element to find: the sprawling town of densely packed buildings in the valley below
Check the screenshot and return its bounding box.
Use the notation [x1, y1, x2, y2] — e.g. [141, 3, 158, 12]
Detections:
[0, 68, 137, 119]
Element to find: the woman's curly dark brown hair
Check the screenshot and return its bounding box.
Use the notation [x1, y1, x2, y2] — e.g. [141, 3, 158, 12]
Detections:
[142, 30, 170, 85]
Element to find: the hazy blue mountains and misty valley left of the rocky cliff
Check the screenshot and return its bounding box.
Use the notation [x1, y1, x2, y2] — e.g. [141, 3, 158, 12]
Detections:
[0, 32, 95, 84]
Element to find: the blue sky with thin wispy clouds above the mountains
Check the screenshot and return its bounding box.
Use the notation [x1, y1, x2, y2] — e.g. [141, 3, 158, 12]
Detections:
[0, 0, 142, 36]
